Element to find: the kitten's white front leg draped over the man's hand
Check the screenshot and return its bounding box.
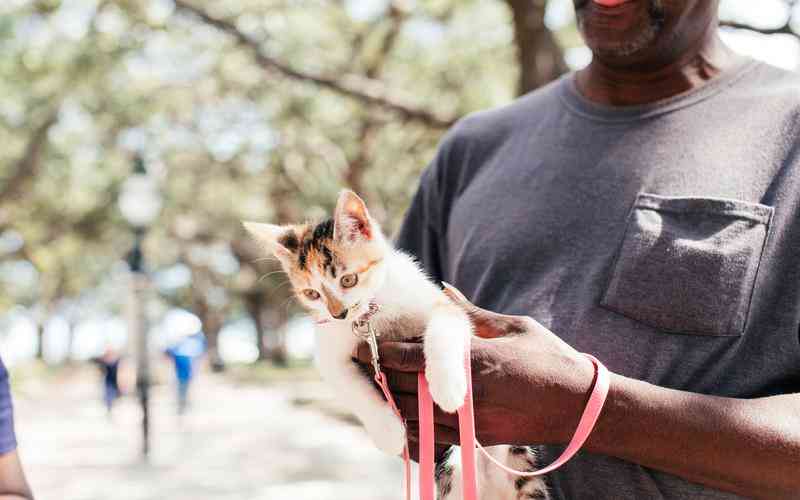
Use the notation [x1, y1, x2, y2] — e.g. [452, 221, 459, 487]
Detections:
[424, 303, 472, 413]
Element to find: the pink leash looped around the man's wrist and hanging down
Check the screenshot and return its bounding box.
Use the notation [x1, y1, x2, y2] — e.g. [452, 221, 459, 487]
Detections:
[375, 350, 610, 500]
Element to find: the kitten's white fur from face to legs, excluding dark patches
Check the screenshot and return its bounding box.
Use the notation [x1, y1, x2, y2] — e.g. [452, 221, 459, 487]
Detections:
[245, 191, 544, 500]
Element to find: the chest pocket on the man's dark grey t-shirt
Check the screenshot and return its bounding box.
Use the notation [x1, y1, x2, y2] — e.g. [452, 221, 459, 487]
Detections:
[600, 193, 773, 336]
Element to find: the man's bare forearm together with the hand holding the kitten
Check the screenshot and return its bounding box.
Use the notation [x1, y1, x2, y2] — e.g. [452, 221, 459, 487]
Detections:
[355, 293, 800, 499]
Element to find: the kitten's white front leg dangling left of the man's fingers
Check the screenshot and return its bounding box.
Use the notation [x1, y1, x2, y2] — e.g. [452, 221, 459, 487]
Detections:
[317, 326, 406, 456]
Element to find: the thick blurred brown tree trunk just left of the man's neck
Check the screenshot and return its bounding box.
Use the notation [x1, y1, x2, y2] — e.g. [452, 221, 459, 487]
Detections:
[506, 0, 568, 95]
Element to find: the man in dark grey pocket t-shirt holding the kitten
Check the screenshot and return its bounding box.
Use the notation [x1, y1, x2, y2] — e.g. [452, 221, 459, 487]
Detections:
[357, 0, 800, 500]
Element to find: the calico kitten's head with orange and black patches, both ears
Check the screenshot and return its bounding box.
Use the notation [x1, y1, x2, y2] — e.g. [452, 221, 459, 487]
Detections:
[244, 190, 389, 321]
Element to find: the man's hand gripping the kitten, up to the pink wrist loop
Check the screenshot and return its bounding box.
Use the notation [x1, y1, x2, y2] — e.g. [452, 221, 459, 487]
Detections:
[355, 287, 594, 452]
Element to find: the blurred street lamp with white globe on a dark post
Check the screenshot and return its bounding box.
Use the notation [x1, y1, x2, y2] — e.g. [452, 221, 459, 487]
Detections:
[119, 154, 161, 458]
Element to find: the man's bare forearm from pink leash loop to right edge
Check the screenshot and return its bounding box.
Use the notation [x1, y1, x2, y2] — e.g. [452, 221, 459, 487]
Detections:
[586, 374, 800, 499]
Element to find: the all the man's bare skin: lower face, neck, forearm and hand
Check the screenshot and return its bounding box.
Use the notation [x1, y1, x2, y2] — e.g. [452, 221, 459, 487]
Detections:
[354, 0, 800, 499]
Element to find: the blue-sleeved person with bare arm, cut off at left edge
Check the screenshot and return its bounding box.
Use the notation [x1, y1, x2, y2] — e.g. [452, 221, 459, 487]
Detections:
[0, 359, 33, 500]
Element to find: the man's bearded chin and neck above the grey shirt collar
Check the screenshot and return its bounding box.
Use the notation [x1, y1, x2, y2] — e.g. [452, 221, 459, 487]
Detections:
[575, 0, 740, 106]
